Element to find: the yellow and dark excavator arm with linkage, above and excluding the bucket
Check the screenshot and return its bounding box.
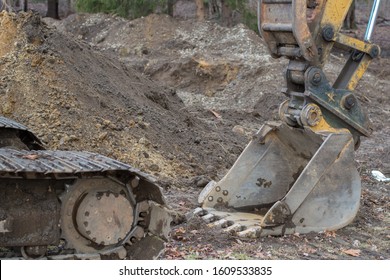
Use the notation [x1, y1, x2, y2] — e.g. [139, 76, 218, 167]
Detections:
[259, 0, 380, 143]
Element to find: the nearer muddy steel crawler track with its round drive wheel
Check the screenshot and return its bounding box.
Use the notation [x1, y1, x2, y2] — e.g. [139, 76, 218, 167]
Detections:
[0, 148, 165, 259]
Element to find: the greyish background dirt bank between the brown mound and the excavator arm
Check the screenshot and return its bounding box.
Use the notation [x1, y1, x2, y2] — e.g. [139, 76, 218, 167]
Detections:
[49, 14, 286, 120]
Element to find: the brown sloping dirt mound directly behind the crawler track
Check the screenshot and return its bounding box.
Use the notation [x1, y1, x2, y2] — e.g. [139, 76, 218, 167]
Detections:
[0, 13, 246, 187]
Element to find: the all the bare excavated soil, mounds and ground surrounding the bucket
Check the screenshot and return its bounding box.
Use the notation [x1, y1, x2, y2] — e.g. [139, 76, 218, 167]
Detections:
[0, 10, 390, 259]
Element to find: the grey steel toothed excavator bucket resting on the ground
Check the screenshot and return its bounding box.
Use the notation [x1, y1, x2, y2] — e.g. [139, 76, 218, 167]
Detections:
[194, 123, 361, 238]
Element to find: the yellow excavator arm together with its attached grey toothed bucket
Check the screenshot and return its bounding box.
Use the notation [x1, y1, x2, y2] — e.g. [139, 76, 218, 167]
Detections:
[194, 0, 380, 237]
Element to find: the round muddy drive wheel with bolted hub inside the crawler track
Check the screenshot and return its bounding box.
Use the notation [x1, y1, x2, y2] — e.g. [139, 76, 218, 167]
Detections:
[61, 178, 149, 258]
